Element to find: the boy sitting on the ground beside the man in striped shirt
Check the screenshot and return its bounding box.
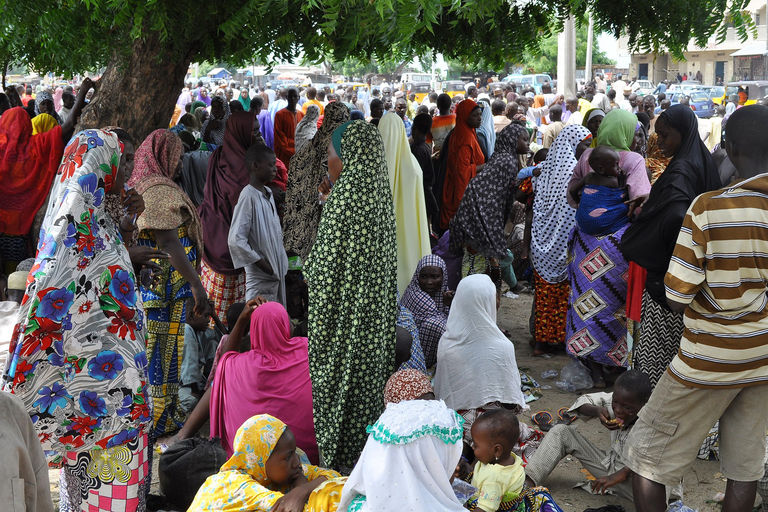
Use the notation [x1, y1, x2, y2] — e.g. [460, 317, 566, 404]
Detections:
[525, 370, 651, 500]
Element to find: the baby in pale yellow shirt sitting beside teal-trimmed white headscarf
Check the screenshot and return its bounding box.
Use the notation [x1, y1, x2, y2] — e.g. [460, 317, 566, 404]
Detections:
[472, 409, 525, 512]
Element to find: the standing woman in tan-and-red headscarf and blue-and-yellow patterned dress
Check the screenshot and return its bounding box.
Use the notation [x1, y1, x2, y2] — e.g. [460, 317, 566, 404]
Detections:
[128, 130, 210, 440]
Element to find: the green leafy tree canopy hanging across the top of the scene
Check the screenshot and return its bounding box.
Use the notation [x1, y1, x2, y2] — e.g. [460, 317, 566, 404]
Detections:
[0, 0, 751, 77]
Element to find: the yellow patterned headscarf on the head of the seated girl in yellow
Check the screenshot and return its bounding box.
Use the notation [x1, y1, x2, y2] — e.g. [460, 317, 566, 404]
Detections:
[221, 414, 286, 485]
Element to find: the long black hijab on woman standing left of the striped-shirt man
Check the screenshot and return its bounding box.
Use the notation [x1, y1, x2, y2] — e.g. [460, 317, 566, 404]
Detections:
[621, 105, 722, 305]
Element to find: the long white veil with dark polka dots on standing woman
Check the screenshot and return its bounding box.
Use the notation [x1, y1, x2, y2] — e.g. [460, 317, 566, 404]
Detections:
[531, 124, 590, 284]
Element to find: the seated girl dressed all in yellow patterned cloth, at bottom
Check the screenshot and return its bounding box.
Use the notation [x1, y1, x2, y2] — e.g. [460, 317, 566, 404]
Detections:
[188, 414, 346, 512]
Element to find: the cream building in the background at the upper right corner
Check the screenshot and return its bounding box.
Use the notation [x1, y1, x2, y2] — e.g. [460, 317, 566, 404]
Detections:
[620, 0, 768, 84]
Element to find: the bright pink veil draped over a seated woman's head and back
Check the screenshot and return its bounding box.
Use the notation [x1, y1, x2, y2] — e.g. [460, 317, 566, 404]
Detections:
[210, 302, 318, 464]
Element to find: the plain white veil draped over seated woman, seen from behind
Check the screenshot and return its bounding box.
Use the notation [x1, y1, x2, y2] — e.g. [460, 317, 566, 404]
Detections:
[434, 274, 526, 410]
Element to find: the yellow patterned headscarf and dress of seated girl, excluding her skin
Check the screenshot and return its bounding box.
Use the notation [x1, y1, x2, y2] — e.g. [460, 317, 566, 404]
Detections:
[188, 414, 347, 512]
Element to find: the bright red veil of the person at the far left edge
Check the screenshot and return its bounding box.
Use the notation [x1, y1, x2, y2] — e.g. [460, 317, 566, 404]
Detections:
[0, 107, 64, 235]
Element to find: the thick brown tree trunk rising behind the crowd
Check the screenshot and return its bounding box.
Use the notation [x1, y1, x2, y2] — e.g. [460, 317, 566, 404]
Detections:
[77, 34, 193, 146]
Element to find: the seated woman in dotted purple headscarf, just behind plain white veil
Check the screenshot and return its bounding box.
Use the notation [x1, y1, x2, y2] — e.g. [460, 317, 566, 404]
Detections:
[400, 254, 453, 368]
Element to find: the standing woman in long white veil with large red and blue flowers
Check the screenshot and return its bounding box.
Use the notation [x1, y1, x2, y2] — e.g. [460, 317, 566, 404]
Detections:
[5, 130, 151, 512]
